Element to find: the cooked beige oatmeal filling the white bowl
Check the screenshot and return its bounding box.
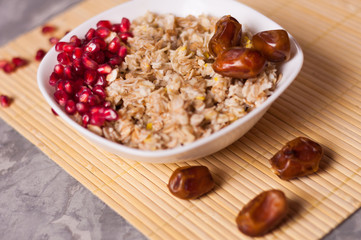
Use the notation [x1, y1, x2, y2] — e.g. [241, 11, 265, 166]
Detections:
[102, 12, 278, 150]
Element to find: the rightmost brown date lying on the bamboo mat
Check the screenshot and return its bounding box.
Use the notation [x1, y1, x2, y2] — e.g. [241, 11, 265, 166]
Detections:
[270, 137, 323, 180]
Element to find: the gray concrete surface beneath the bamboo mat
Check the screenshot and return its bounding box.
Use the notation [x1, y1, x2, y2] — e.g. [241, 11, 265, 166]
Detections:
[0, 0, 361, 240]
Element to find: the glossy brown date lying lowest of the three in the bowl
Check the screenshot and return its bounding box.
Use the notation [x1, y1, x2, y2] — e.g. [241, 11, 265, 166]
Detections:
[212, 47, 266, 79]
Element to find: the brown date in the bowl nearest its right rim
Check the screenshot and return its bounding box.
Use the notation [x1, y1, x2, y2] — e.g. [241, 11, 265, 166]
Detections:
[252, 30, 291, 62]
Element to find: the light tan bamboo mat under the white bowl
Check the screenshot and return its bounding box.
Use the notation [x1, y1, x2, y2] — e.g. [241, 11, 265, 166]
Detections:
[0, 0, 361, 239]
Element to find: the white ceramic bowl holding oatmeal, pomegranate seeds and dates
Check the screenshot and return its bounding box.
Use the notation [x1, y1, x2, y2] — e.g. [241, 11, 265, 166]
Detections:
[37, 0, 303, 163]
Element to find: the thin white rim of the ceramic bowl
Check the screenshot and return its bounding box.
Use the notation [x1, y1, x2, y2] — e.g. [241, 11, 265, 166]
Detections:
[37, 0, 304, 158]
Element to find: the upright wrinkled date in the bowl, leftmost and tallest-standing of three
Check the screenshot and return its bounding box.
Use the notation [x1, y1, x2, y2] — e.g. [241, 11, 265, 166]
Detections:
[208, 15, 242, 57]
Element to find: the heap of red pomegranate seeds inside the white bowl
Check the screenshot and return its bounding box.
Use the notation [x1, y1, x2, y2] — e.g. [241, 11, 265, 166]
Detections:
[49, 18, 132, 127]
